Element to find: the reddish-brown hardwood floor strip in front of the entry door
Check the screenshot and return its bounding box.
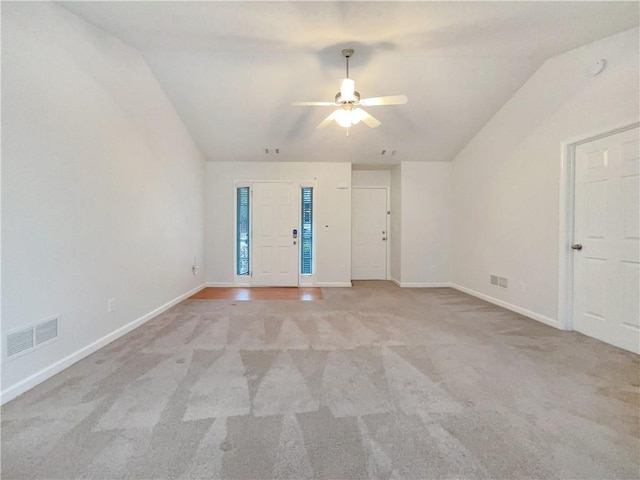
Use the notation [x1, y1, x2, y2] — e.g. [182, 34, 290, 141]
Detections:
[190, 287, 322, 300]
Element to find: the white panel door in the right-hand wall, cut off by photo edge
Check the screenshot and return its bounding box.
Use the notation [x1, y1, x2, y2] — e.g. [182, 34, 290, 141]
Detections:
[573, 128, 640, 353]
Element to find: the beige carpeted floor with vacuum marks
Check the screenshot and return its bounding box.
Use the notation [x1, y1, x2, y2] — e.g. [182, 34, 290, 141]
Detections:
[2, 282, 640, 479]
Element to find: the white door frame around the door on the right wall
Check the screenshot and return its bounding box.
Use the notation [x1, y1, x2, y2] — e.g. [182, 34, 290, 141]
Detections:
[558, 118, 640, 330]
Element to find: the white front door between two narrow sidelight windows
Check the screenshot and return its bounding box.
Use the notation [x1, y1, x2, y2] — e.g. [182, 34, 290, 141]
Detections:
[251, 183, 300, 287]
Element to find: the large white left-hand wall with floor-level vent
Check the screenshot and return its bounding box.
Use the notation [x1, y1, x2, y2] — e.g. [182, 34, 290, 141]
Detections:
[2, 2, 204, 401]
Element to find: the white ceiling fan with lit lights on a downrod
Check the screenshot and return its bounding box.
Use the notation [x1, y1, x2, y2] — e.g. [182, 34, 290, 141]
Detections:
[292, 48, 408, 135]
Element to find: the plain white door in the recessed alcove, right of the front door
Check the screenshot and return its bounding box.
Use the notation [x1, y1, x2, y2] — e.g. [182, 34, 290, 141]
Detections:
[351, 188, 388, 280]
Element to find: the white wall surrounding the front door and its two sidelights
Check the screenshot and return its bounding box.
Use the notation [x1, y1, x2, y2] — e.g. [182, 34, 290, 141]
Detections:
[206, 162, 351, 286]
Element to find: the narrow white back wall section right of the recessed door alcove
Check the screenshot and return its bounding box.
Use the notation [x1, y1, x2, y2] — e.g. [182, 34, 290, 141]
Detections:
[392, 162, 452, 287]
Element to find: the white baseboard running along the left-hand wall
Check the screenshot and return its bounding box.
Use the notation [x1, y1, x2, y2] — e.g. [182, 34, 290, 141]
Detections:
[0, 285, 204, 405]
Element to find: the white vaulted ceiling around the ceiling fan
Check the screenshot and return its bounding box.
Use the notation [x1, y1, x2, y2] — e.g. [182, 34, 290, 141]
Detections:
[59, 1, 640, 165]
